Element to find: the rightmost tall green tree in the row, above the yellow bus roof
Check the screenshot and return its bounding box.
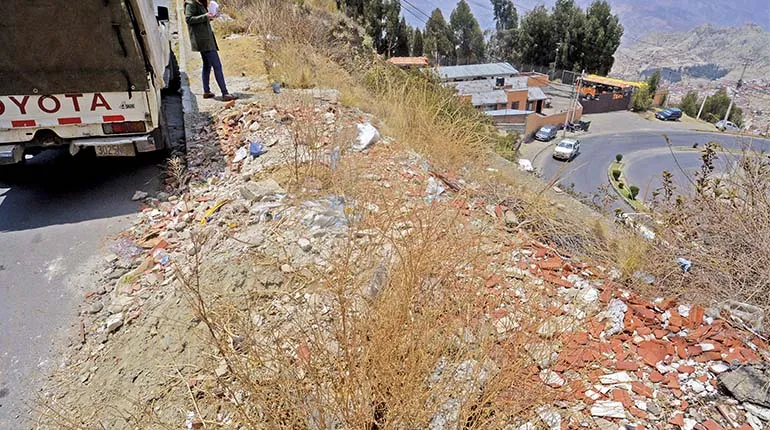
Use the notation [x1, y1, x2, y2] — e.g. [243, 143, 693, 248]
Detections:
[581, 0, 623, 75]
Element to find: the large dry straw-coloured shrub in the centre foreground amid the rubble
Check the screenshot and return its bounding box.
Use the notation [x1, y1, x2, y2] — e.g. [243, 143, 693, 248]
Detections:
[180, 197, 549, 429]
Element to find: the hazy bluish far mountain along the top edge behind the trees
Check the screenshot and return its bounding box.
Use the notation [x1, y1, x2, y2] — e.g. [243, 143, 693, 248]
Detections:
[401, 0, 770, 39]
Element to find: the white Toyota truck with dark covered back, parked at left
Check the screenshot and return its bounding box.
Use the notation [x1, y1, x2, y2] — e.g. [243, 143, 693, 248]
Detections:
[0, 0, 179, 164]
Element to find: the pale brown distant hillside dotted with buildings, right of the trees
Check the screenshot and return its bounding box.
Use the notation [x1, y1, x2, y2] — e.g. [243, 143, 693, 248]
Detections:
[611, 24, 770, 82]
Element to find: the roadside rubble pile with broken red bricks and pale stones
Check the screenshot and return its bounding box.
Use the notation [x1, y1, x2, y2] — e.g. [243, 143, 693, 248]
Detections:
[40, 89, 770, 430]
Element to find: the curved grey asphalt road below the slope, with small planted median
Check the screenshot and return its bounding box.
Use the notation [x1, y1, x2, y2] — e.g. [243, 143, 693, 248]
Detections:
[534, 131, 770, 207]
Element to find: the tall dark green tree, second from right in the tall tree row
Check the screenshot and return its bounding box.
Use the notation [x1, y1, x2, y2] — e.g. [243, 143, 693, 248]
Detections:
[551, 0, 586, 70]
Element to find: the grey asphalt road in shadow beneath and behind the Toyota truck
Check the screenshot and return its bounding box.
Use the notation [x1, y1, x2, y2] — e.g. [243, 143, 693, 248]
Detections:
[0, 91, 184, 430]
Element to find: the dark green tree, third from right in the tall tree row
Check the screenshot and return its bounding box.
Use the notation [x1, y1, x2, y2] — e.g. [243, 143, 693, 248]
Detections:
[517, 5, 556, 66]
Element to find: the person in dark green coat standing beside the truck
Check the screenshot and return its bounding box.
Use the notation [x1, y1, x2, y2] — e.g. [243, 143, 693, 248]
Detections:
[184, 0, 236, 101]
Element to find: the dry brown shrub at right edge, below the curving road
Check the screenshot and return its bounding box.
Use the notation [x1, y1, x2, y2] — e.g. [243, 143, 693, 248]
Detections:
[645, 139, 770, 312]
